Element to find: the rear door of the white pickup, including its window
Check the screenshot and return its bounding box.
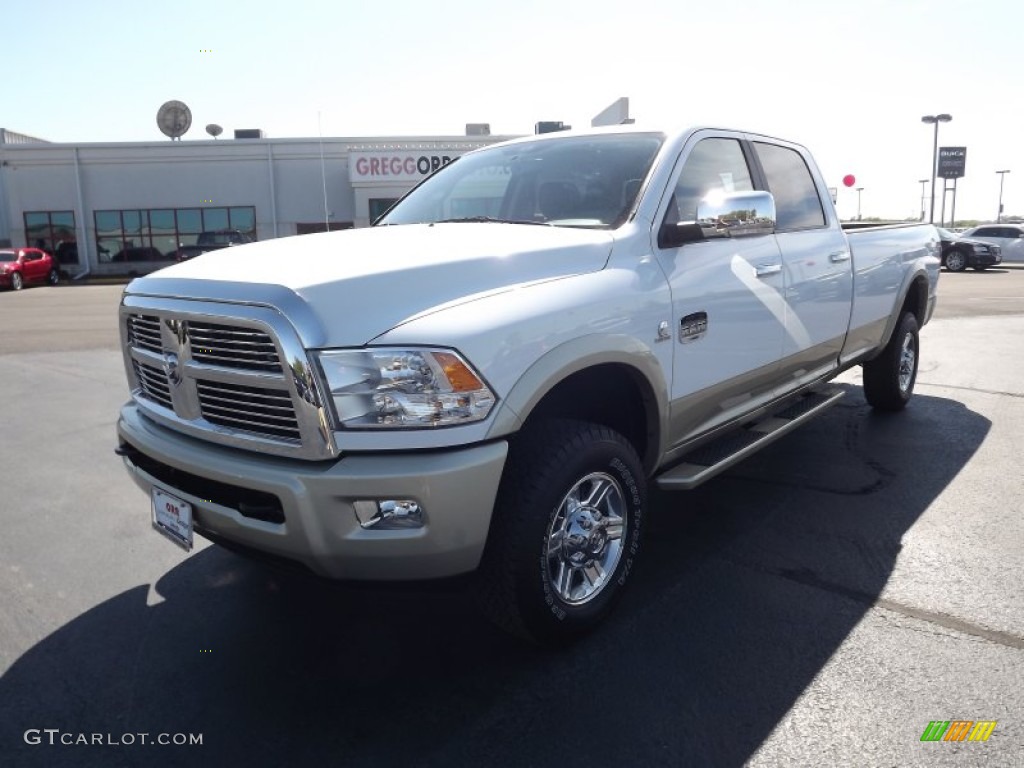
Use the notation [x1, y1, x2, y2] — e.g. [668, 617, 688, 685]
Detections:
[753, 139, 853, 391]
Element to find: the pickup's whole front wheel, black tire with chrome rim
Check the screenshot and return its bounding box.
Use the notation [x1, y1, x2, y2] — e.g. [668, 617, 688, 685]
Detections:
[477, 419, 647, 645]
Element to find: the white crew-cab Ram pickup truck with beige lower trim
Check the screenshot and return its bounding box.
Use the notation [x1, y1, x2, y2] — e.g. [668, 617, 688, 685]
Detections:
[118, 128, 939, 642]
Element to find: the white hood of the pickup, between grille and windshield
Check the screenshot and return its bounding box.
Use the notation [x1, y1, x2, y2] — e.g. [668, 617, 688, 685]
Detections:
[127, 222, 612, 347]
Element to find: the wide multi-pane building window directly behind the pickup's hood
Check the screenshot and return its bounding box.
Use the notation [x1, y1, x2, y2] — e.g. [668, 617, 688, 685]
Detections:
[94, 206, 256, 263]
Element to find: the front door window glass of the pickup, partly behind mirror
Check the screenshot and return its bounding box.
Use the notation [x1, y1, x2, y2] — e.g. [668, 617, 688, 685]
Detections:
[666, 138, 754, 223]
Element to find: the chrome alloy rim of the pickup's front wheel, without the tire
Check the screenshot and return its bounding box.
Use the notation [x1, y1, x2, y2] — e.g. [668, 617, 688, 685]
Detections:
[546, 472, 626, 605]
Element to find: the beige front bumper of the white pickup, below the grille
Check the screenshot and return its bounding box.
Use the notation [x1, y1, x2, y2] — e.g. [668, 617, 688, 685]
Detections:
[117, 402, 508, 581]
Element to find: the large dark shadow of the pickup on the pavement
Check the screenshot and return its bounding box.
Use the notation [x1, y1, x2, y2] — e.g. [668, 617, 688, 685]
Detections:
[0, 387, 990, 767]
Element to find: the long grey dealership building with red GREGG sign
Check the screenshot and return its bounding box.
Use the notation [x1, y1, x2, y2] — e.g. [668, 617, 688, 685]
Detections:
[0, 128, 511, 275]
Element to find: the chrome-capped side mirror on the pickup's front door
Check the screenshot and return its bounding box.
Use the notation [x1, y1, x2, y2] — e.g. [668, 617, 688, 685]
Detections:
[657, 191, 775, 248]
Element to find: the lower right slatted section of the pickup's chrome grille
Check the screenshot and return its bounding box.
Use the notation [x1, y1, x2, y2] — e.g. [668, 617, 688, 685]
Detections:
[196, 380, 302, 440]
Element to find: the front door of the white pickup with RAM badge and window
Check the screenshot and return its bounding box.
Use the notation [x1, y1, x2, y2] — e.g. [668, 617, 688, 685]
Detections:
[654, 131, 785, 446]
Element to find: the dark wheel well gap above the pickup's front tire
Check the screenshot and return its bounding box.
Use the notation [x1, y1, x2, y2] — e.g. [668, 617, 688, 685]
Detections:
[526, 364, 660, 472]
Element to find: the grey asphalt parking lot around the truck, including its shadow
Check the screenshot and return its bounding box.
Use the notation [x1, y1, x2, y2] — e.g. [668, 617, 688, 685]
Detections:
[0, 266, 1024, 768]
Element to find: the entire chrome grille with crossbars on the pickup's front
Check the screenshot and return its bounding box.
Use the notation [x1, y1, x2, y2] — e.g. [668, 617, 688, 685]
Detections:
[121, 295, 338, 460]
